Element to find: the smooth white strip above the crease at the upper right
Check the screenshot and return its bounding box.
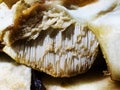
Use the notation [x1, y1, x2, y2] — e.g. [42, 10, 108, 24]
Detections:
[61, 0, 119, 25]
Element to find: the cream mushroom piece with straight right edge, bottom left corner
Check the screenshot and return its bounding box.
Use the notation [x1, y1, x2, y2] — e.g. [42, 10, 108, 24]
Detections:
[0, 53, 31, 90]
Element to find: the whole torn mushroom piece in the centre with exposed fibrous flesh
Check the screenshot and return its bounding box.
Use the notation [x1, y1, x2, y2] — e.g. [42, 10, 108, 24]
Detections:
[3, 0, 98, 77]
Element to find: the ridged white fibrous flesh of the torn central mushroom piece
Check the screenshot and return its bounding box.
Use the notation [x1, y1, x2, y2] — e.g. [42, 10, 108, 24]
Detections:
[4, 23, 98, 77]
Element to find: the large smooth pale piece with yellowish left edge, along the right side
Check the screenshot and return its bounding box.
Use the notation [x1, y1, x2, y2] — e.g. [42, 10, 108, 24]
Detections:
[89, 3, 120, 80]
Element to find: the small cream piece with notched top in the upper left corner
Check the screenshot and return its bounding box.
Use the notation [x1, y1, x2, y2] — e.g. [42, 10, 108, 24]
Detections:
[0, 2, 22, 33]
